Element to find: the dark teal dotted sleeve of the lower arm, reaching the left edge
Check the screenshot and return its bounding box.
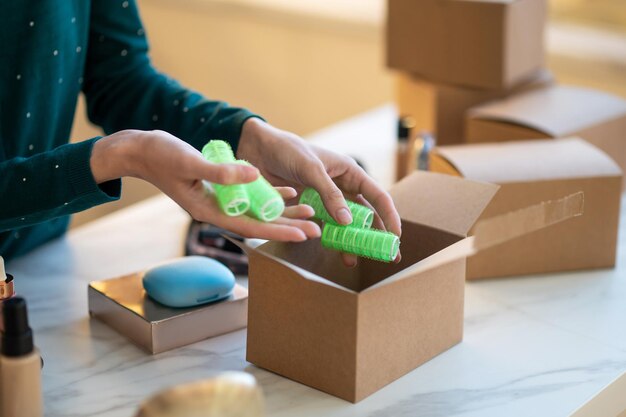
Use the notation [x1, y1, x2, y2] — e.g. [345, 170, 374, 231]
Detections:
[0, 138, 121, 232]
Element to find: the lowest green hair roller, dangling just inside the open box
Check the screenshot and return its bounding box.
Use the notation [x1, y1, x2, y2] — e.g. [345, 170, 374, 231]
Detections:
[322, 223, 400, 262]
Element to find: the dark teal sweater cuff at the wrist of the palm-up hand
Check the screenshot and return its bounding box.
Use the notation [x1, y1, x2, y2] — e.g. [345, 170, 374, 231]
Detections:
[62, 136, 122, 206]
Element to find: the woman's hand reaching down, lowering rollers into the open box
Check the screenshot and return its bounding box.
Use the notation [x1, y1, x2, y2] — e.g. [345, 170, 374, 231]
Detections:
[237, 118, 402, 266]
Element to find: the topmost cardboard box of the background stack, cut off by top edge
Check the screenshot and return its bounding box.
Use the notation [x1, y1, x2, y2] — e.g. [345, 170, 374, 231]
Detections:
[387, 0, 546, 89]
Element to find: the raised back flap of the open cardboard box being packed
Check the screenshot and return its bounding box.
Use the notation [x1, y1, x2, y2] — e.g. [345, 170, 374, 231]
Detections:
[390, 171, 499, 236]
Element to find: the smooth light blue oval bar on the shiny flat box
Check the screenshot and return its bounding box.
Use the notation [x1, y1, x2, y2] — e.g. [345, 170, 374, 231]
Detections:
[143, 256, 235, 307]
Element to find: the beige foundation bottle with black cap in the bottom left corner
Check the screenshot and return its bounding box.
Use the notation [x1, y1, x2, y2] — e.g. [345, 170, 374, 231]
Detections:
[0, 297, 43, 417]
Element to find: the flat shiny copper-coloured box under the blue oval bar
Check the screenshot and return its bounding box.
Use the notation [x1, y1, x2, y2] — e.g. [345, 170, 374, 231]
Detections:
[87, 273, 248, 354]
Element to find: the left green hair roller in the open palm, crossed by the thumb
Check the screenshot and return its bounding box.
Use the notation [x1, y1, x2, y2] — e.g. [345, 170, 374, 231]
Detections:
[202, 140, 250, 216]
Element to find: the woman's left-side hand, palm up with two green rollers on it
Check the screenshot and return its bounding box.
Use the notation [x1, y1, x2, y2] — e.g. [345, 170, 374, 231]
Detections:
[90, 130, 321, 242]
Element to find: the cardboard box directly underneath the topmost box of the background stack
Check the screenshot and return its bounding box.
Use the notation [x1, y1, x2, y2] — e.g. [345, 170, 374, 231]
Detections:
[395, 69, 554, 145]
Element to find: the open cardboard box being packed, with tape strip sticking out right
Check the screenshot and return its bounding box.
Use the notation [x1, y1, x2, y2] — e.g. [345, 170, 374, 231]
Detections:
[242, 172, 582, 402]
